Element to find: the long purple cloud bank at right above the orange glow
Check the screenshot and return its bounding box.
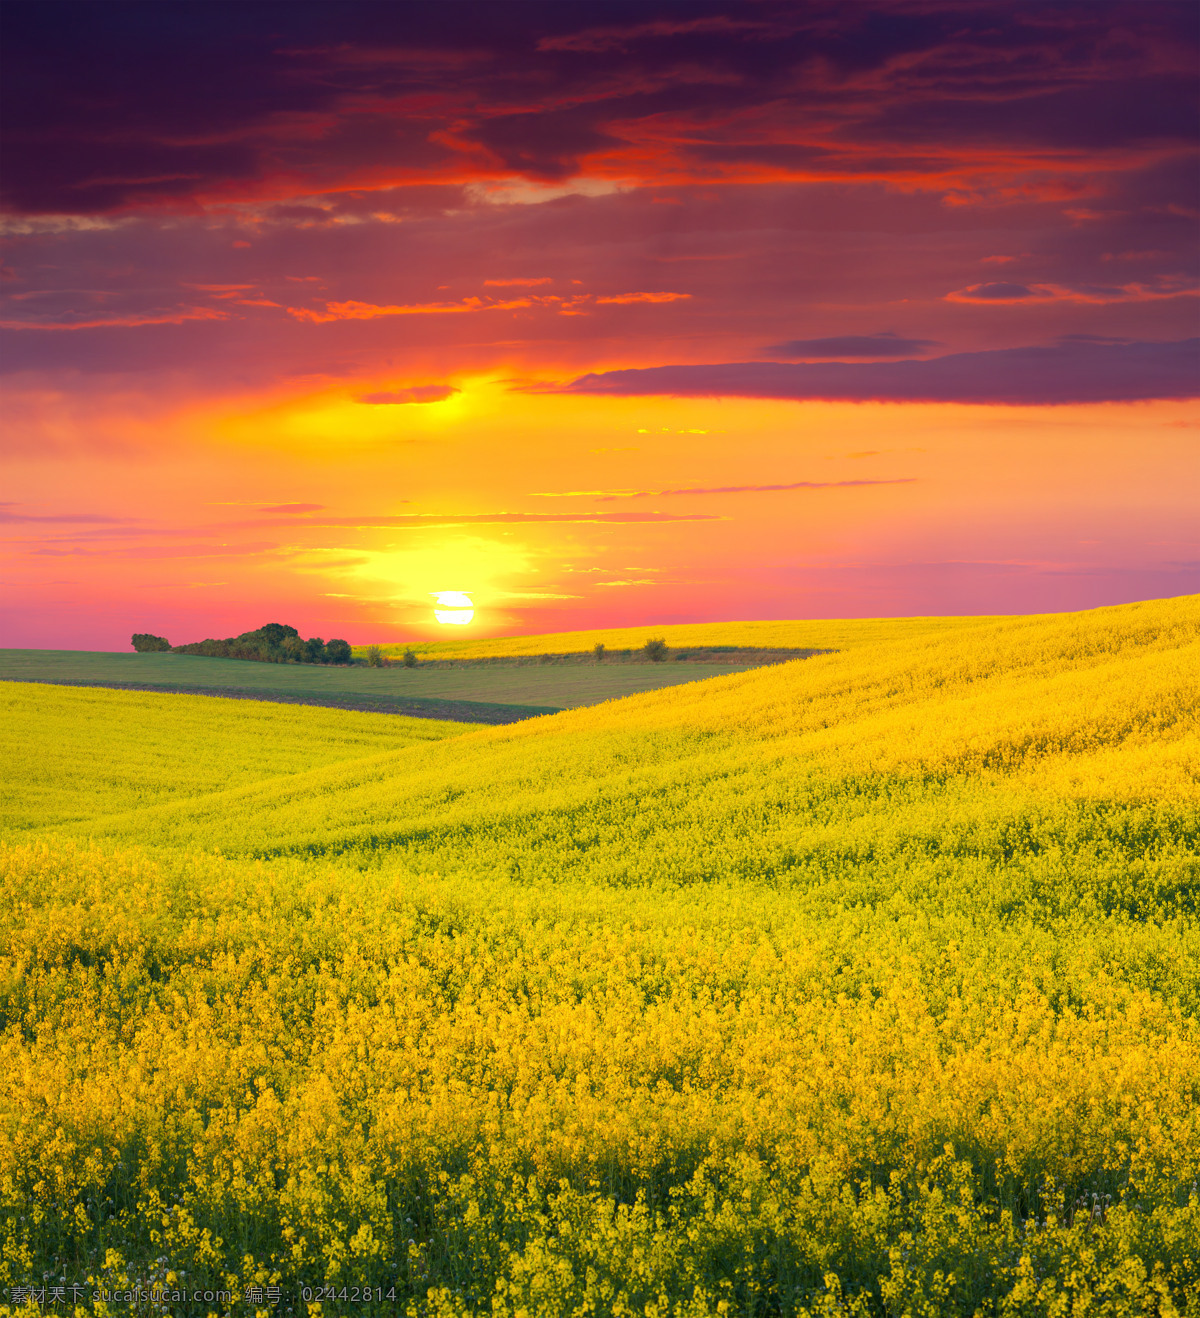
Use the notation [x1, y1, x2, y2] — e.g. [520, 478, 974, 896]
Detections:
[564, 339, 1200, 406]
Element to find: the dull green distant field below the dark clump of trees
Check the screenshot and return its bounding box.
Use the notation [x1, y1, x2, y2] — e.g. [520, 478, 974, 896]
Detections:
[0, 650, 780, 722]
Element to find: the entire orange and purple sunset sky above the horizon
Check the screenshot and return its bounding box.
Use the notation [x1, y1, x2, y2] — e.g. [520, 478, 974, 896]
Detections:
[0, 0, 1200, 650]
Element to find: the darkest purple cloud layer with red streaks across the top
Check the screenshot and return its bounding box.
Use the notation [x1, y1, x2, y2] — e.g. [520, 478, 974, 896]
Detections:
[4, 0, 1196, 219]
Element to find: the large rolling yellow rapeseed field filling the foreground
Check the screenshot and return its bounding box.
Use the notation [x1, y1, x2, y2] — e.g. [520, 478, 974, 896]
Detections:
[0, 597, 1200, 1318]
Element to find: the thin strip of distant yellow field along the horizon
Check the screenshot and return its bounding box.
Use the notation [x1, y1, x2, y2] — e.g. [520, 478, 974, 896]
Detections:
[353, 617, 1002, 659]
